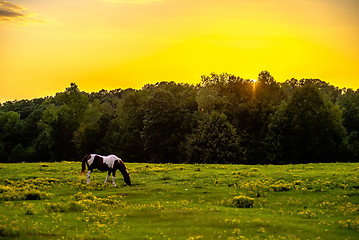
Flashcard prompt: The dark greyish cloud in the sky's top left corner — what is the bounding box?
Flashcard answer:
[0,1,42,22]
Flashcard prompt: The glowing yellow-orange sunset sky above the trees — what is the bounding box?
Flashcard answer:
[0,0,359,102]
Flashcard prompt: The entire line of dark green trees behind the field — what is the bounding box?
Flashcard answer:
[0,71,359,164]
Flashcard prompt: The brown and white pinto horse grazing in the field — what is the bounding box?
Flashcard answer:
[81,154,131,187]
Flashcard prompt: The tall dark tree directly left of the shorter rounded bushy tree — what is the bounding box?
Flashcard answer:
[141,82,198,162]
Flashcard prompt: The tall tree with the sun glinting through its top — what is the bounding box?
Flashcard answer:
[232,71,288,164]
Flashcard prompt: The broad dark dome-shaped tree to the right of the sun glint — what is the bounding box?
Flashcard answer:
[267,84,345,163]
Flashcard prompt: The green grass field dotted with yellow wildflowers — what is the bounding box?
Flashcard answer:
[0,162,359,239]
